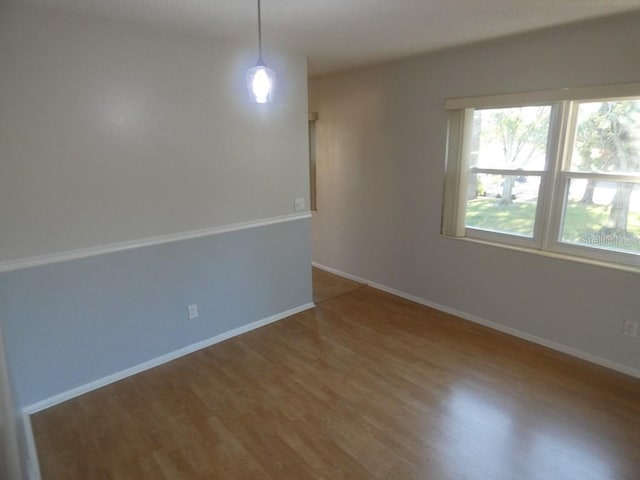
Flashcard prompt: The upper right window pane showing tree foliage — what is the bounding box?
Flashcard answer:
[571,100,640,174]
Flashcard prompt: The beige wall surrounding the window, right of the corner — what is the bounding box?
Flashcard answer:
[309,10,640,370]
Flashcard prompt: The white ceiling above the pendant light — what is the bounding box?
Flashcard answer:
[13,0,640,74]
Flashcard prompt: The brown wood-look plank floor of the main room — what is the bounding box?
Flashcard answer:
[32,272,640,480]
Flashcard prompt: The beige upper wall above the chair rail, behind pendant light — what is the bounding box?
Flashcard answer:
[0,7,308,263]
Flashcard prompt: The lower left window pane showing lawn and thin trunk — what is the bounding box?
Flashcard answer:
[465,174,540,238]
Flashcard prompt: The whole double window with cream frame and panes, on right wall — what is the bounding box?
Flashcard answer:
[443,84,640,267]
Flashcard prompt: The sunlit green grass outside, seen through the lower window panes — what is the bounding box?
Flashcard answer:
[466,198,640,251]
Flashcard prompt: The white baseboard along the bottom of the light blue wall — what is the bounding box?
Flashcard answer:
[22,303,315,414]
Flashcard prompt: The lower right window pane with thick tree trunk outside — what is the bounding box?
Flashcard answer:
[561,179,640,254]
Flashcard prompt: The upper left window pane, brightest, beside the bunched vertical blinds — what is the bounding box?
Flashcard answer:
[470,106,551,170]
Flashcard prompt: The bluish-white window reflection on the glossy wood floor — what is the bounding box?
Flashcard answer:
[442,387,613,480]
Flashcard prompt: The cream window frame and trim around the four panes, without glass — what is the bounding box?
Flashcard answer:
[441,83,640,270]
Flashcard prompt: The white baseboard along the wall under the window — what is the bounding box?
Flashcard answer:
[312,262,640,378]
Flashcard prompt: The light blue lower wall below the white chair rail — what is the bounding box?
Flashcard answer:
[0,219,312,407]
